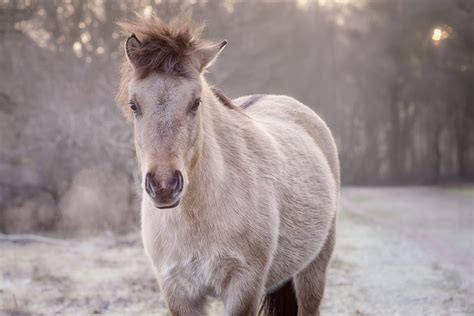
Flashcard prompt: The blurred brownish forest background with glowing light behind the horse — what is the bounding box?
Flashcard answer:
[0,0,474,233]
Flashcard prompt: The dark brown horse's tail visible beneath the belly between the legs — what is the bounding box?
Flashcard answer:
[259,279,298,316]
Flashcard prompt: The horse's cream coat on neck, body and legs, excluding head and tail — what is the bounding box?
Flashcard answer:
[139,80,339,315]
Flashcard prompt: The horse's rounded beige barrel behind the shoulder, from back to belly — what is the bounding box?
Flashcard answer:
[234,95,339,289]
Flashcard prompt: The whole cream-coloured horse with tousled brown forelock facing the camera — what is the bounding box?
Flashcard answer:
[117,15,340,316]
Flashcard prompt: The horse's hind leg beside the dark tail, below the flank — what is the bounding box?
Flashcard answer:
[294,220,336,316]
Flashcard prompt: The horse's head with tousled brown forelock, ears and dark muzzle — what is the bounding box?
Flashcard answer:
[115,17,226,208]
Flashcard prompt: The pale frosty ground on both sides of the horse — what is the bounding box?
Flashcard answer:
[0,186,474,316]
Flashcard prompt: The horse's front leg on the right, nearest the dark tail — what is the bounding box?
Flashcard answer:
[223,272,266,316]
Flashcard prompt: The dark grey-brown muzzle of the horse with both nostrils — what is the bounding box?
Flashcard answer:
[145,170,184,209]
